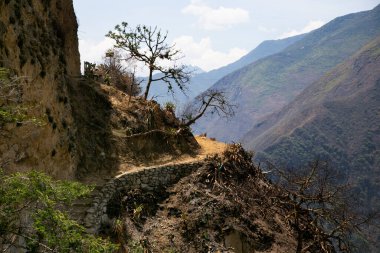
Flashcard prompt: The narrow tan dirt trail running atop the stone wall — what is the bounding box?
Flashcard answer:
[82,136,227,185]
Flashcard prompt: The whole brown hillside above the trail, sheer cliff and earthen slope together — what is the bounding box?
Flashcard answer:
[0,0,199,179]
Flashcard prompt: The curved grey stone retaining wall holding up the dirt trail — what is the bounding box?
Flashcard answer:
[84,161,203,234]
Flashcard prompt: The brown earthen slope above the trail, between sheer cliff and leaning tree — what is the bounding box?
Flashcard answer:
[70,79,199,180]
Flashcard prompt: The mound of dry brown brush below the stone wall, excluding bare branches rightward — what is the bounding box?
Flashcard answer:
[105,144,295,252]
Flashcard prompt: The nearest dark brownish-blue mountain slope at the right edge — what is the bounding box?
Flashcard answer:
[244,37,380,204]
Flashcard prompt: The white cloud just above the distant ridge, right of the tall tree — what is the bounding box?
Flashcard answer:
[174,36,248,71]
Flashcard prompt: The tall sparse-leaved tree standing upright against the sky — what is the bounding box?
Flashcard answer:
[106,22,190,99]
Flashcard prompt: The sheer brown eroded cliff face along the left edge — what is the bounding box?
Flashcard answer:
[0,0,80,178]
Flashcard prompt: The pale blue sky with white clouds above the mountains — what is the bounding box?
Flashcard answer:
[74,0,380,71]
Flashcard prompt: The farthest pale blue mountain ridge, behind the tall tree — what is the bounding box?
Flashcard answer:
[145,35,304,105]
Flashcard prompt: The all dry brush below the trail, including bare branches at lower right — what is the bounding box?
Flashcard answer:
[97,144,376,253]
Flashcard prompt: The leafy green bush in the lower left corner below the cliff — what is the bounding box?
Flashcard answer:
[0,171,118,253]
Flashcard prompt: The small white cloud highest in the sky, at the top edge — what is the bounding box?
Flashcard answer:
[182,0,249,30]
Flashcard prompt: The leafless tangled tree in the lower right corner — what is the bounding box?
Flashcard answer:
[270,161,378,253]
